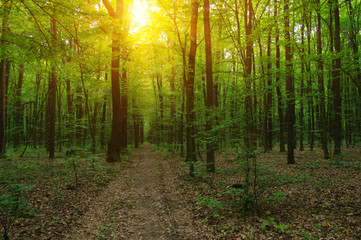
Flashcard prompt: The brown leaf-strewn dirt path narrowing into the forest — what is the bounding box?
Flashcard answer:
[67,144,200,240]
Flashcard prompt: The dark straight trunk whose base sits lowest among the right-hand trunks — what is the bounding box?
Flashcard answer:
[284,0,295,164]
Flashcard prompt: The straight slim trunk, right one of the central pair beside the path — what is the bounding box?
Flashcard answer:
[203,0,215,172]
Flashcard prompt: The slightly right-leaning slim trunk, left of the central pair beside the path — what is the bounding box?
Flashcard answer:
[186,0,199,176]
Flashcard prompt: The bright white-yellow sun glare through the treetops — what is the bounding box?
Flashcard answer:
[131,0,150,32]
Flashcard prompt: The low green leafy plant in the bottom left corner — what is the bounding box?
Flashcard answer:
[0,184,35,239]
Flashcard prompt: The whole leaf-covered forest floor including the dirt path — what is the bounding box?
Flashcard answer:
[0,144,361,240]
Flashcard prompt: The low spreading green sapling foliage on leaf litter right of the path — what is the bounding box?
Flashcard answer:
[201,150,310,215]
